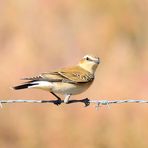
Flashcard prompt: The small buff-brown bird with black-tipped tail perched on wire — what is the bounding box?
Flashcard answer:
[12,55,100,105]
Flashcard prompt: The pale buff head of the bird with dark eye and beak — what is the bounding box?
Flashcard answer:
[79,55,100,74]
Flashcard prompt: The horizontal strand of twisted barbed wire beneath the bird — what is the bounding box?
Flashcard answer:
[0,98,148,108]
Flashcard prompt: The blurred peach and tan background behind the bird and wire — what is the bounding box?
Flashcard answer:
[0,0,148,148]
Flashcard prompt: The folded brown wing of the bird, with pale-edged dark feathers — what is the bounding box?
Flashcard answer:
[22,67,94,83]
